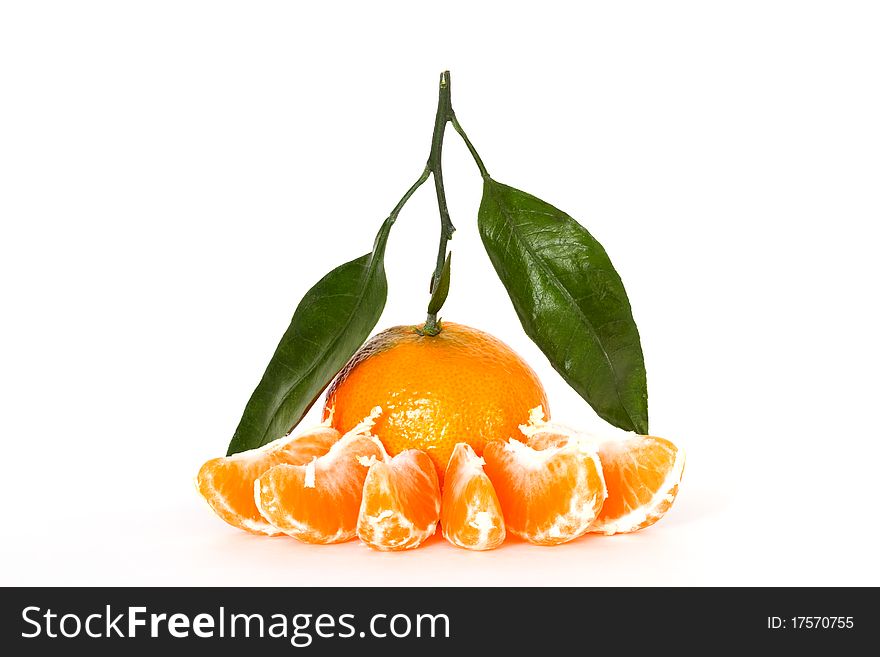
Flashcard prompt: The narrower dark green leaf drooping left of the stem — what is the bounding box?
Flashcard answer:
[227,218,394,455]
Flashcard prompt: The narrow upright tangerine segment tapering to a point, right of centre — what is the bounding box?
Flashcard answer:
[440,443,507,550]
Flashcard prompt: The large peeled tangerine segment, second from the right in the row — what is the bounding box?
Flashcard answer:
[483,409,606,545]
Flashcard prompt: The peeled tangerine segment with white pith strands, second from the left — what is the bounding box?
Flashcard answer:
[251,409,387,543]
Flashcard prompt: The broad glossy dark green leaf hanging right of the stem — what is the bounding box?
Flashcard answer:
[479,179,648,434]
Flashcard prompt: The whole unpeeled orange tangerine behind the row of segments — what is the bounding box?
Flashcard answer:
[324,322,549,478]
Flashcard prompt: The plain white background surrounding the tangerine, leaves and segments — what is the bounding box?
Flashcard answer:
[0,1,880,585]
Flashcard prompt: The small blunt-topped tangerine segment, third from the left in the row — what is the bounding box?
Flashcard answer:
[357,449,440,550]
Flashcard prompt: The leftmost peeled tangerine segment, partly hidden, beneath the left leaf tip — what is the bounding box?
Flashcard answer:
[196,426,340,536]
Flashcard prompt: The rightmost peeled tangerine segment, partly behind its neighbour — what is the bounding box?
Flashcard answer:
[590,434,685,535]
